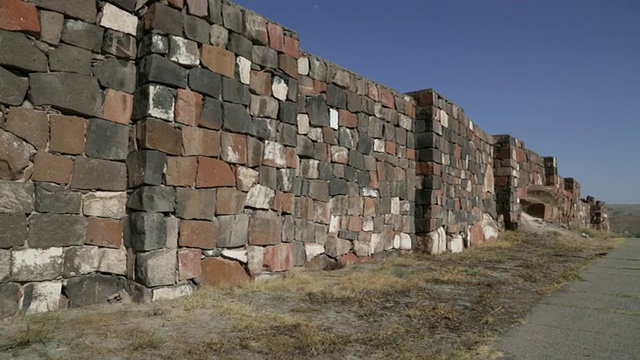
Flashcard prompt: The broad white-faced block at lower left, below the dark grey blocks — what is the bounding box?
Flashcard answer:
[11,248,64,281]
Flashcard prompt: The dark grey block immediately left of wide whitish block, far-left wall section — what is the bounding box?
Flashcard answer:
[35,182,82,214]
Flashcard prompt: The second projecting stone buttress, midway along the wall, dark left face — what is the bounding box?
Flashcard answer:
[411,90,496,253]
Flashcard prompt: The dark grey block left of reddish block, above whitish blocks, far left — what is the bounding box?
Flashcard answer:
[29,214,87,248]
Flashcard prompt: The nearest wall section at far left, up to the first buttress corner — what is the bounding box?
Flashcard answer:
[0,0,138,316]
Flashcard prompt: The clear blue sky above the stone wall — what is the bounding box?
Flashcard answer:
[237,0,640,203]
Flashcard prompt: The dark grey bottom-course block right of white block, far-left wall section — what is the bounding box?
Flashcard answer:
[64,274,125,308]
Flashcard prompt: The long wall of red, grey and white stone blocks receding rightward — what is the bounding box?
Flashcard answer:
[0,0,603,316]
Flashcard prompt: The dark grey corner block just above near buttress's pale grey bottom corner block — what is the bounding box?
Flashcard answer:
[129,212,167,251]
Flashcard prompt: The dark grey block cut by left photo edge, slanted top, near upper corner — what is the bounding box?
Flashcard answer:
[0,30,47,71]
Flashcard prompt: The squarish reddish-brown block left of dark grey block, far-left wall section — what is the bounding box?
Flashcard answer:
[49,115,86,155]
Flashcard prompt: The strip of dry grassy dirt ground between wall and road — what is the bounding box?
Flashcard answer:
[0,231,622,360]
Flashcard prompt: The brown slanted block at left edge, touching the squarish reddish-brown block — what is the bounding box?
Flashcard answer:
[5,107,49,150]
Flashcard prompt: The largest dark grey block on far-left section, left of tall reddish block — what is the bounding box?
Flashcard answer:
[29,73,102,117]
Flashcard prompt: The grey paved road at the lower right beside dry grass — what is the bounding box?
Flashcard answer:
[497,239,640,360]
